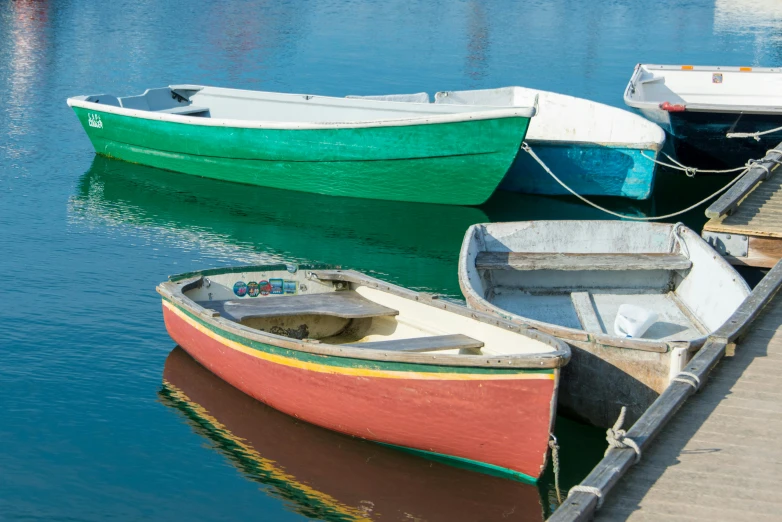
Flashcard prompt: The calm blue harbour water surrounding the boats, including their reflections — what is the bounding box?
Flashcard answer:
[0,0,782,521]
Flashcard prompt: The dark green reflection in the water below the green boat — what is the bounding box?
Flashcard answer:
[70,156,488,295]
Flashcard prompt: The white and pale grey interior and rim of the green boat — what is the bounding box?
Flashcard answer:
[75,85,534,123]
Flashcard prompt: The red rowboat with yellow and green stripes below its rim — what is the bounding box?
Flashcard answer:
[157,265,570,481]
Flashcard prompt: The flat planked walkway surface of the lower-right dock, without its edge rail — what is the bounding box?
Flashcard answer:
[595,297,782,521]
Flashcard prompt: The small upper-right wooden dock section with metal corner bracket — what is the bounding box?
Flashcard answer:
[703,143,782,268]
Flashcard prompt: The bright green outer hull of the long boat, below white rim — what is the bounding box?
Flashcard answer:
[73,107,529,205]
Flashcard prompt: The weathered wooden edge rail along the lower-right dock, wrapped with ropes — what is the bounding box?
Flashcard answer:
[549,261,782,522]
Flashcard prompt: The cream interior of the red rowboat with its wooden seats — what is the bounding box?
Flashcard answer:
[179,270,557,355]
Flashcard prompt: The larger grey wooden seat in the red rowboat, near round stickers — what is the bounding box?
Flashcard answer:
[198,291,399,322]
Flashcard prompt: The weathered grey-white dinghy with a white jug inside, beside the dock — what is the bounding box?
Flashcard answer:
[459,221,750,427]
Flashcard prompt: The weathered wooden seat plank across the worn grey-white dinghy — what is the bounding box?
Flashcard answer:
[475,252,692,271]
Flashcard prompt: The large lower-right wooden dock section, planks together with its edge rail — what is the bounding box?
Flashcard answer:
[549,263,782,521]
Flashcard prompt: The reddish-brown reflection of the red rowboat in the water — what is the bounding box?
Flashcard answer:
[159,347,543,522]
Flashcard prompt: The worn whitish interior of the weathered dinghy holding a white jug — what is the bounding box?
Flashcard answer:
[460,221,749,341]
